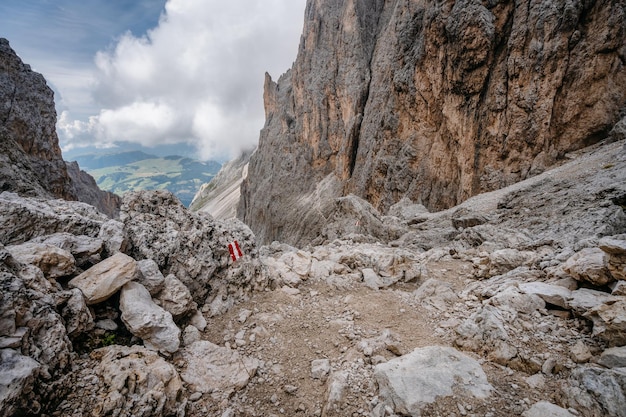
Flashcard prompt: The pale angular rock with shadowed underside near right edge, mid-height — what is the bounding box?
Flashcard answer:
[563,248,613,286]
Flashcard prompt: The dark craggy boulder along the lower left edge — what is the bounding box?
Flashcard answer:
[0,244,73,415]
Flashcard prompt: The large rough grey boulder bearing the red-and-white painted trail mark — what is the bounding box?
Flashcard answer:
[120,191,267,315]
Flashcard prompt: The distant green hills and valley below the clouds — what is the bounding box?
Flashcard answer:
[74,151,221,207]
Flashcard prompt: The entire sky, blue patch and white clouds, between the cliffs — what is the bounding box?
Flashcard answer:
[0,0,306,159]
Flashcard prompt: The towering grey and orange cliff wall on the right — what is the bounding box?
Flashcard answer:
[238,0,626,244]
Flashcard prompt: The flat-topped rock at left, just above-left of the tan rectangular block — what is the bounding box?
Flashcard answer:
[6,242,76,279]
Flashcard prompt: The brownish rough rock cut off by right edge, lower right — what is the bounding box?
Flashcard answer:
[585,298,626,347]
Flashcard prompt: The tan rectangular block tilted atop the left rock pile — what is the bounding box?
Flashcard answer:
[68,253,138,305]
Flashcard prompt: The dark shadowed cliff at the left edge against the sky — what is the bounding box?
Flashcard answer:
[0,39,120,215]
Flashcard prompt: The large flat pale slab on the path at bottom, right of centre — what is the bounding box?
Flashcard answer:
[374,346,493,416]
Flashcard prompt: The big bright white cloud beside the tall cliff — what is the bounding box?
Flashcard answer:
[58,0,305,158]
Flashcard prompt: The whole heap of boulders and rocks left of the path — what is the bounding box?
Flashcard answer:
[0,192,266,415]
